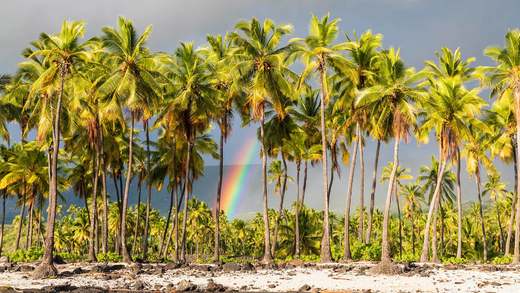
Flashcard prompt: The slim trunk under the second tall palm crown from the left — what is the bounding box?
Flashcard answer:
[121,112,135,263]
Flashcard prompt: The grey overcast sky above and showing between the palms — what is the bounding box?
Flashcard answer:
[0,0,520,217]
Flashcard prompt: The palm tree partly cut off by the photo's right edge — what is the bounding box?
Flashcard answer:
[484,29,520,263]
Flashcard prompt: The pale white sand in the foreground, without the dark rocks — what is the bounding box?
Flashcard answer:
[0,264,520,292]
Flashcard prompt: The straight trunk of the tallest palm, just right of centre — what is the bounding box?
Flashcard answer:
[320,66,332,262]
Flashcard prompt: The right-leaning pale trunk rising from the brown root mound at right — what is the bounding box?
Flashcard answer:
[381,136,400,263]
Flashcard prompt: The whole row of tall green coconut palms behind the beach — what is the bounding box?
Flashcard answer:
[0,15,520,276]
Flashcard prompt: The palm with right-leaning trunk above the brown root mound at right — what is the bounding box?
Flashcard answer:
[356,48,423,265]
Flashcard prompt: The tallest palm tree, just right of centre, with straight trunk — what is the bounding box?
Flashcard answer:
[291,15,354,262]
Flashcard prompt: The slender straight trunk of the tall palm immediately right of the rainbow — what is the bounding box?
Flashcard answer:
[260,105,273,264]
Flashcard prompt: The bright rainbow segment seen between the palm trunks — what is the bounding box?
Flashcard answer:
[221,137,258,218]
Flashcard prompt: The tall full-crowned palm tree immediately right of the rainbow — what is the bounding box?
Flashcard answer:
[231,18,293,263]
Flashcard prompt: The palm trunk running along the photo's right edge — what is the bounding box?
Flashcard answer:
[513,84,520,264]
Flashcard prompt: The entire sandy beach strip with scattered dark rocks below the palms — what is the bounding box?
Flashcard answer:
[0,263,520,292]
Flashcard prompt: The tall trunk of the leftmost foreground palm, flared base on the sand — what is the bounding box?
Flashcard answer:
[34,68,66,278]
